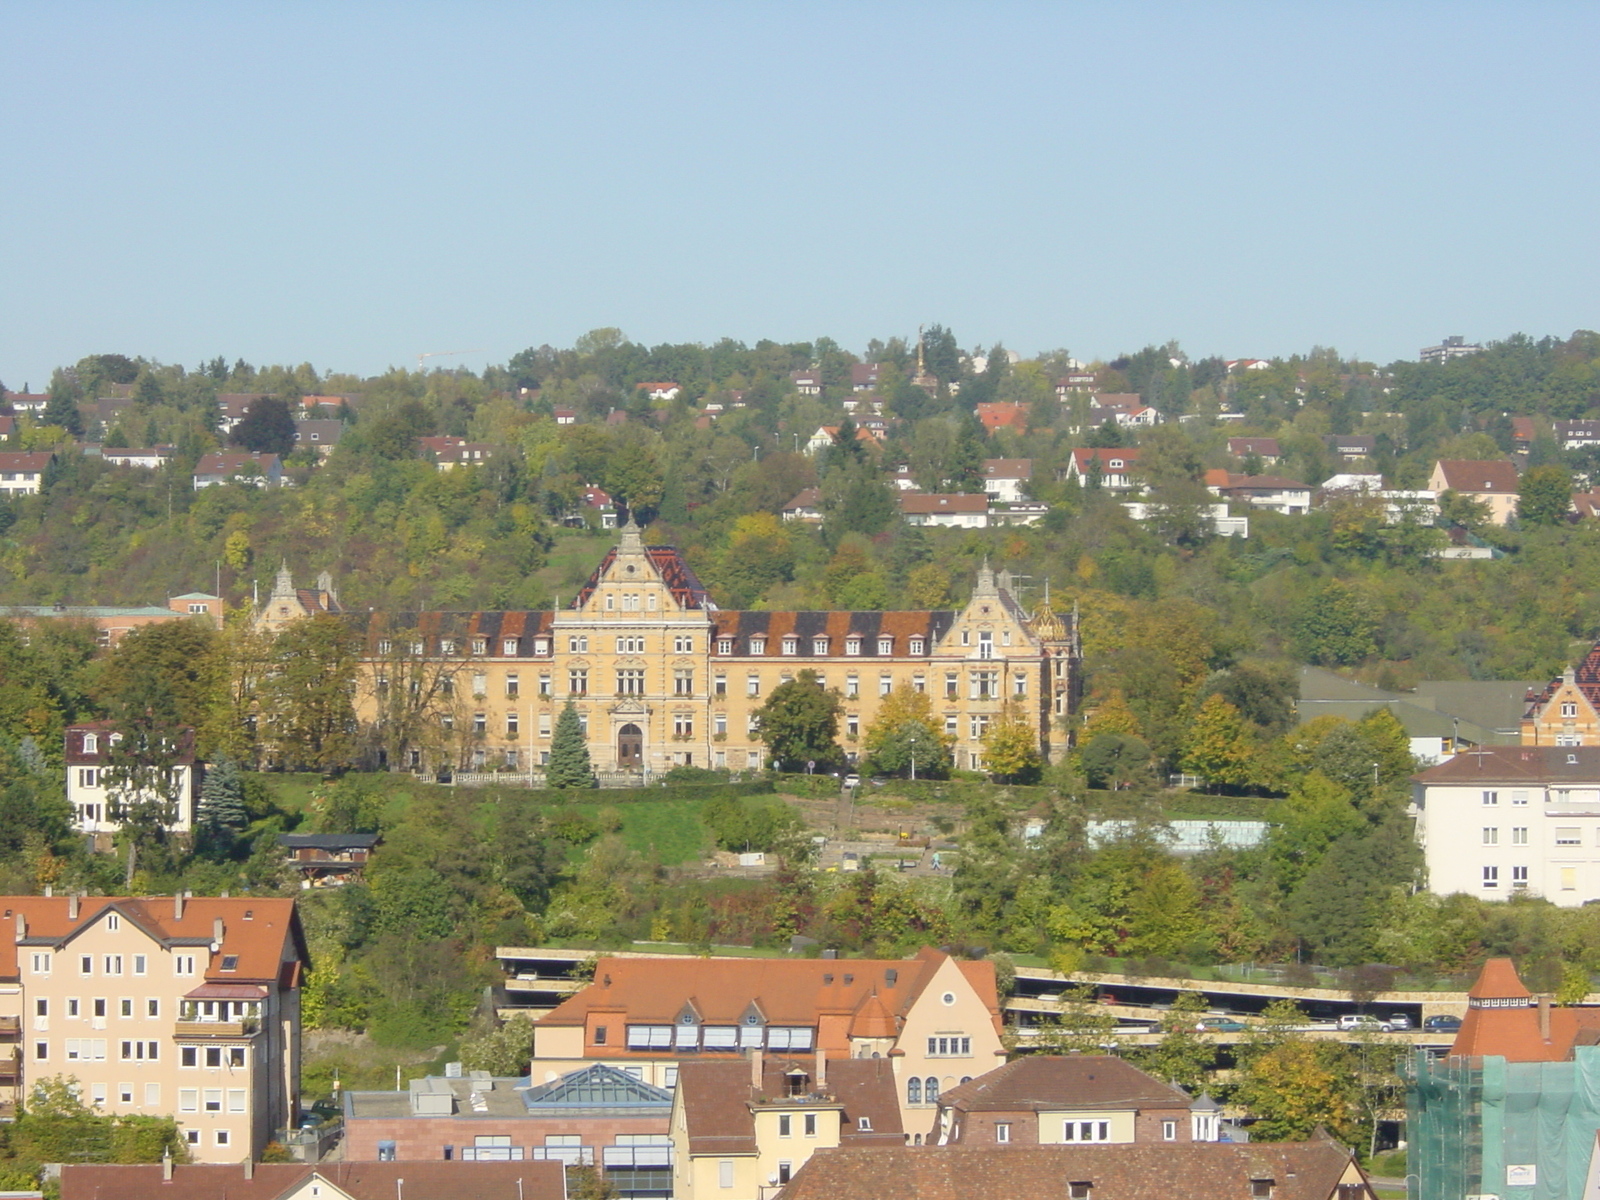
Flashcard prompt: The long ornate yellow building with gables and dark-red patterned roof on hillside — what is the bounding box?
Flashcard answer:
[312,525,1080,782]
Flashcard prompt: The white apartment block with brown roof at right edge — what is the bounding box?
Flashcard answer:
[1414,746,1600,909]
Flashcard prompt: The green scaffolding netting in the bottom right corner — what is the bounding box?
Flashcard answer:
[1406,1046,1600,1200]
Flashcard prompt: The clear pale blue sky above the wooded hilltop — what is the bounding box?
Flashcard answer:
[0,0,1600,389]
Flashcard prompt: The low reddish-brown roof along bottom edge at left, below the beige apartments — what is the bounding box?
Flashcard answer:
[61,1158,566,1200]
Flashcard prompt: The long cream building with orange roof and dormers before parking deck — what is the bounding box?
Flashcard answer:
[531,949,1005,1136]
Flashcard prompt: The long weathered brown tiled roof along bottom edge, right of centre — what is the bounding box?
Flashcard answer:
[782,1134,1376,1200]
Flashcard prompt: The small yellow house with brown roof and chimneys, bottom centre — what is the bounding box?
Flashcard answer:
[672,1050,907,1200]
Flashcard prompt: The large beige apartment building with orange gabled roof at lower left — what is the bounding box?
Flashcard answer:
[0,896,307,1163]
